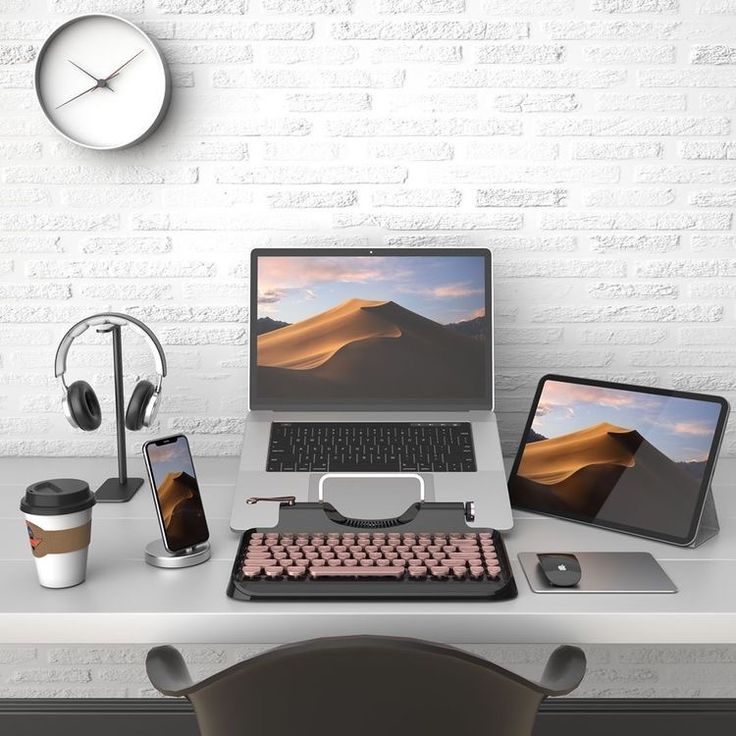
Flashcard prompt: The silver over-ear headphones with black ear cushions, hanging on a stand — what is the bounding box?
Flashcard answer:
[54,312,166,432]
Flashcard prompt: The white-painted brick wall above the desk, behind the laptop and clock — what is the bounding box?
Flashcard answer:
[0,0,736,458]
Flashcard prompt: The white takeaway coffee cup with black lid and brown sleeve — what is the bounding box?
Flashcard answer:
[20,478,95,588]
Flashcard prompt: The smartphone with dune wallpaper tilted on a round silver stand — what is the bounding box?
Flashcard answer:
[143,434,210,552]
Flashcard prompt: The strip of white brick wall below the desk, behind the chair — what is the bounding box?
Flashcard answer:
[0,644,736,698]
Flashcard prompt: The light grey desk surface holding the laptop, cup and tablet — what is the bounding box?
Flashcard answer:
[0,458,736,644]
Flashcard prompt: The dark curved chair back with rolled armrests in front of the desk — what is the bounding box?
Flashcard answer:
[146,636,586,736]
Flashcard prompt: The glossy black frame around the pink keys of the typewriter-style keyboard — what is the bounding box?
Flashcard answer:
[227,502,518,601]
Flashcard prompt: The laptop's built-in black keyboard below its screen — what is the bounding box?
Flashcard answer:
[266,422,476,473]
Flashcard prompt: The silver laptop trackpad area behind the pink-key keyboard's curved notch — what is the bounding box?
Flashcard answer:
[309,473,433,519]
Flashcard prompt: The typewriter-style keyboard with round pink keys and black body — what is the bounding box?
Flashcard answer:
[227,499,516,600]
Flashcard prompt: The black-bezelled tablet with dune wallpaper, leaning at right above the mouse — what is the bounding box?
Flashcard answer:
[509,375,729,546]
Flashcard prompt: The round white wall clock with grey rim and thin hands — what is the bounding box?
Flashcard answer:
[36,15,170,149]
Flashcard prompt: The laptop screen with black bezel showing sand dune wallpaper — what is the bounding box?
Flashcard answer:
[250,249,493,409]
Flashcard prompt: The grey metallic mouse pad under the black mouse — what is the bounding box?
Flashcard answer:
[518,550,677,594]
